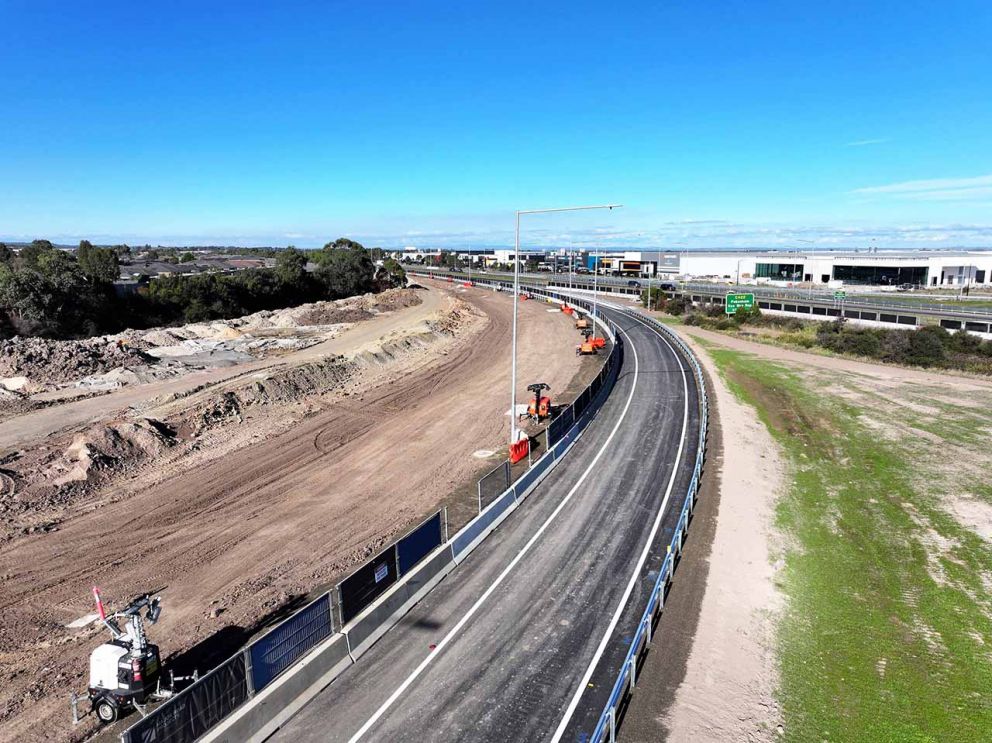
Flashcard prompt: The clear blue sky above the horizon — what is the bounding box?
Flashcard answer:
[0,0,992,247]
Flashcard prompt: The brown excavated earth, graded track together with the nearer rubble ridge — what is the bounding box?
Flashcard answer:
[0,289,594,741]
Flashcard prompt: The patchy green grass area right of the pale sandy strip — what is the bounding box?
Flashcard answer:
[710,349,992,743]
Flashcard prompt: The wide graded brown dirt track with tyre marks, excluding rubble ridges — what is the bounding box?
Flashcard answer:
[0,288,592,741]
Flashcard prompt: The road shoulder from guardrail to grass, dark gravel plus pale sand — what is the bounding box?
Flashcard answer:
[620,328,783,742]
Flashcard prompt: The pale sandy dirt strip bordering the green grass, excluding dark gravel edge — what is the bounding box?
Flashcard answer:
[664,332,783,743]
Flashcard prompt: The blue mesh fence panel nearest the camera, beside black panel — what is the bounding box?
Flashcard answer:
[248,593,334,693]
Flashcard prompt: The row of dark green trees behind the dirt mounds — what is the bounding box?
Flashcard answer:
[0,238,406,338]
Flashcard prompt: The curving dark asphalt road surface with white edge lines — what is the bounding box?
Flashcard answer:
[271,310,699,743]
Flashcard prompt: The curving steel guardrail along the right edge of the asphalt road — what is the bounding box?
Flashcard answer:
[589,309,709,743]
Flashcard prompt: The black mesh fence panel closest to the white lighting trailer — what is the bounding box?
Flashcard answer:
[121,653,248,743]
